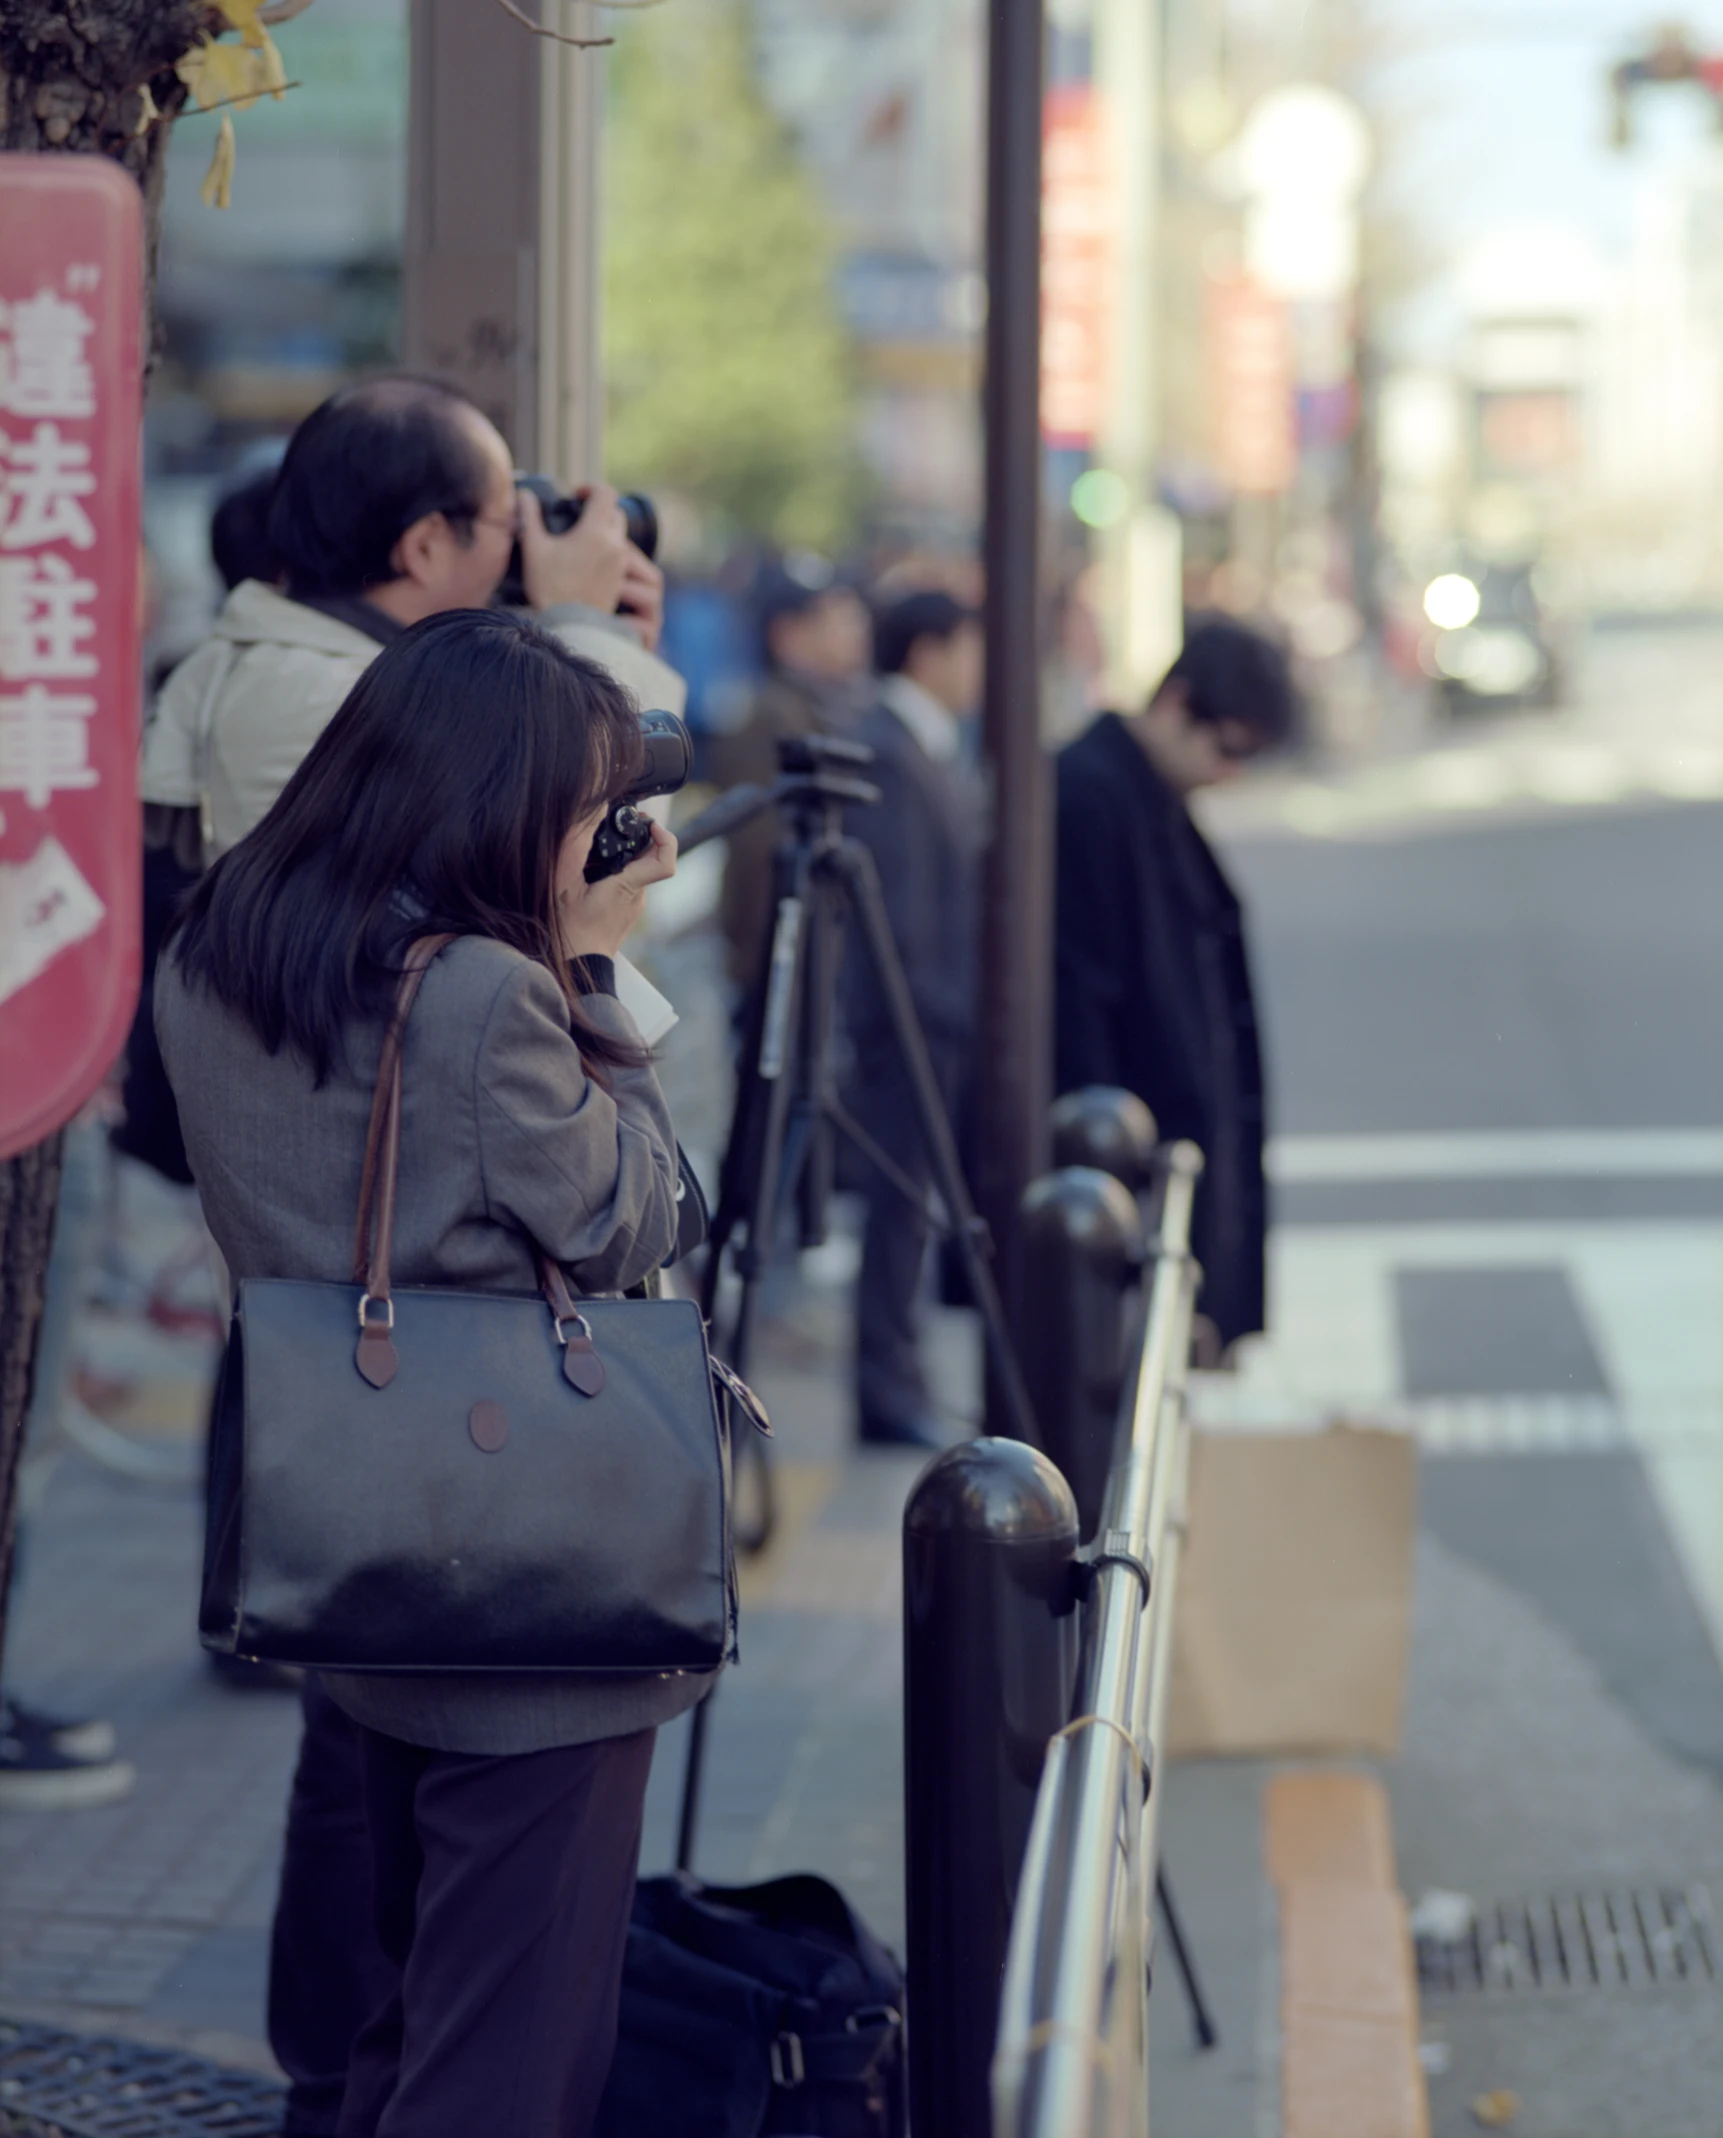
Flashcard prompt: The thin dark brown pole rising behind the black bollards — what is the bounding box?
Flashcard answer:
[975,0,1052,1432]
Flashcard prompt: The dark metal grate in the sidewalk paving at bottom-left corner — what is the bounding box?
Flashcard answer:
[0,2018,282,2138]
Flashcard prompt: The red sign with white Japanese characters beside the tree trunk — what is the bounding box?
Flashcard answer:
[0,154,143,1157]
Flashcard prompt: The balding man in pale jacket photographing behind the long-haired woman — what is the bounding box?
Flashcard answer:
[143,376,684,2138]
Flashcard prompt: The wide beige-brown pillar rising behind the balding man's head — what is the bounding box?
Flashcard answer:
[402,0,605,483]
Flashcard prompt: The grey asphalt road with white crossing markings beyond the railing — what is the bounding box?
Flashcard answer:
[1150,662,1723,2138]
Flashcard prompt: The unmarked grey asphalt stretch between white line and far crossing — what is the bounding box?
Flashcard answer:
[1227,804,1723,1135]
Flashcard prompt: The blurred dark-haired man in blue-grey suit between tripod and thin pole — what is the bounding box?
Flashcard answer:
[842,590,983,1447]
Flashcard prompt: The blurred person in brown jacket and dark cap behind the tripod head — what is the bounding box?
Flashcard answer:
[712,556,868,1003]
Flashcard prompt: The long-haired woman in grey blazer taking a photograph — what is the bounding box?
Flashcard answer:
[156,609,710,2138]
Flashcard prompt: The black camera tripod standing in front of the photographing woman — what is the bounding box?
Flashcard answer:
[676,735,1039,1871]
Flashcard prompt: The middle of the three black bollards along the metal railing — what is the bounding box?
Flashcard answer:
[1020,1171,1144,1539]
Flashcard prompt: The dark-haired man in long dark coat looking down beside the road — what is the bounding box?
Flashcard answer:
[1054,616,1295,1347]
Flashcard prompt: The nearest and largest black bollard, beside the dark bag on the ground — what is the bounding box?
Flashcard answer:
[904,1439,1077,2138]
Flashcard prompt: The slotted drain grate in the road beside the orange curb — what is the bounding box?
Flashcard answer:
[1417,1886,1723,1999]
